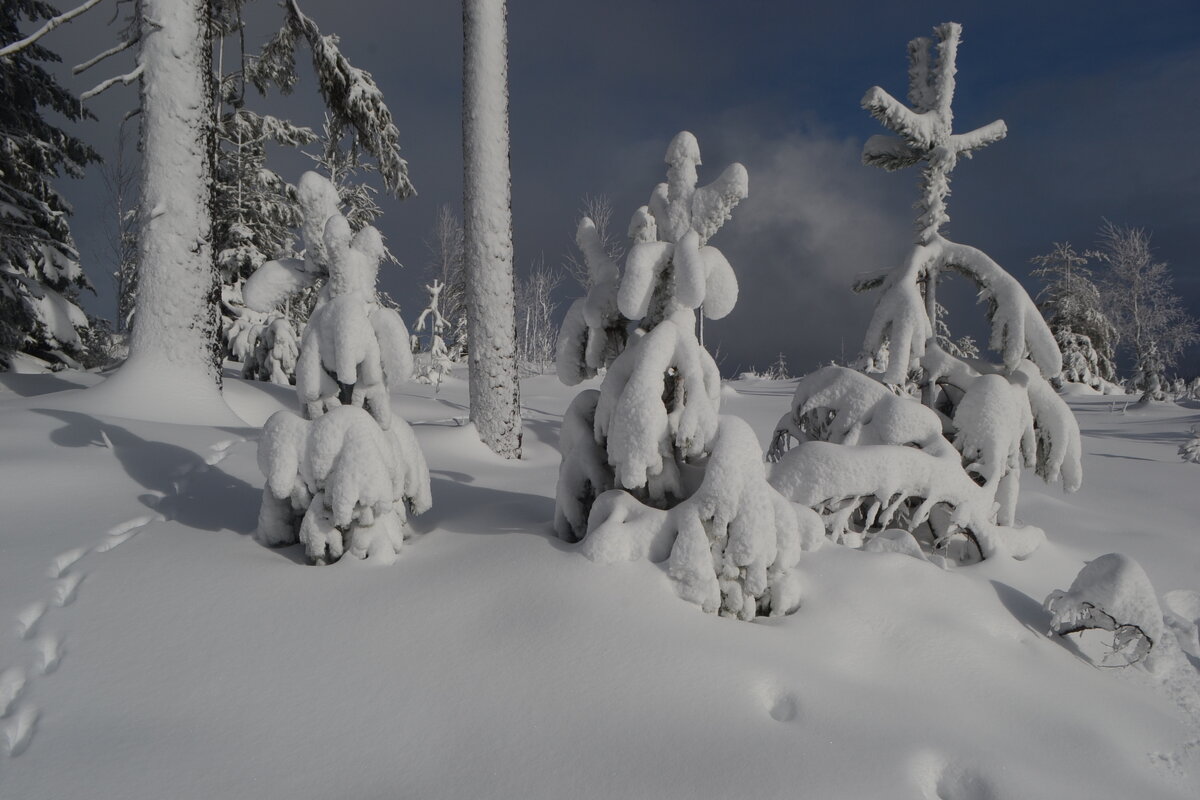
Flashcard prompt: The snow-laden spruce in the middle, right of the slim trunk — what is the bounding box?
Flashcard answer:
[554,132,806,619]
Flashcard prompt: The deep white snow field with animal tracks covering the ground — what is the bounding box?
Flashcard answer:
[0,373,1200,800]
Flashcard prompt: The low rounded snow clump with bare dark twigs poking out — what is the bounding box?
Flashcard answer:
[1045,553,1163,666]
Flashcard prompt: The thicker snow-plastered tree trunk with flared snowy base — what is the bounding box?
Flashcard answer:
[97,0,236,423]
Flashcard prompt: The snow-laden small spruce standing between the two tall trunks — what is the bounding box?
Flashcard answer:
[247,173,430,564]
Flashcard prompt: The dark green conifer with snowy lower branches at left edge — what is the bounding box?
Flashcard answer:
[0,0,98,369]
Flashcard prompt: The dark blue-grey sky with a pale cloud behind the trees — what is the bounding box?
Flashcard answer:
[47,0,1200,373]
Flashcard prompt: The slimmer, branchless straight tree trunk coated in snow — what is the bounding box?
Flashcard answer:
[462,0,521,458]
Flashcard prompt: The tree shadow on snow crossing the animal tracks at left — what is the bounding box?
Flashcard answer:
[32,409,262,534]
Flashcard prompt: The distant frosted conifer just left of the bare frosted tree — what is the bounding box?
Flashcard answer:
[1031,242,1117,389]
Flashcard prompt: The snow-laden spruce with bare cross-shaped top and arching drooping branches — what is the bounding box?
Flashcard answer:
[770,23,1081,558]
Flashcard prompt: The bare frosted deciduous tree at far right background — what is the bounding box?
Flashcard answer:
[1088,222,1200,401]
